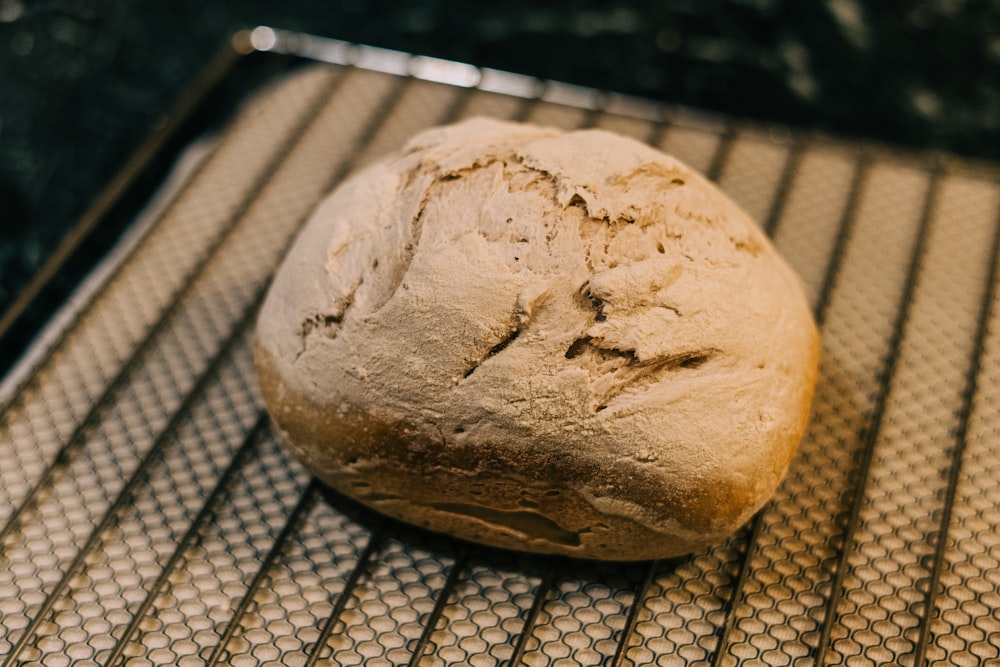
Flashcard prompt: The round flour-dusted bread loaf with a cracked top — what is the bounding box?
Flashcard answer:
[255,119,818,560]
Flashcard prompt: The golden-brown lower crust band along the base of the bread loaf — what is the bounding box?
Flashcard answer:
[254,320,819,561]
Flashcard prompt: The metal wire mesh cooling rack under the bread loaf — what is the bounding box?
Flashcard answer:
[0,34,1000,667]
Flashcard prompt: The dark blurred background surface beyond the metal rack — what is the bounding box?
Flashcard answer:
[0,0,1000,350]
